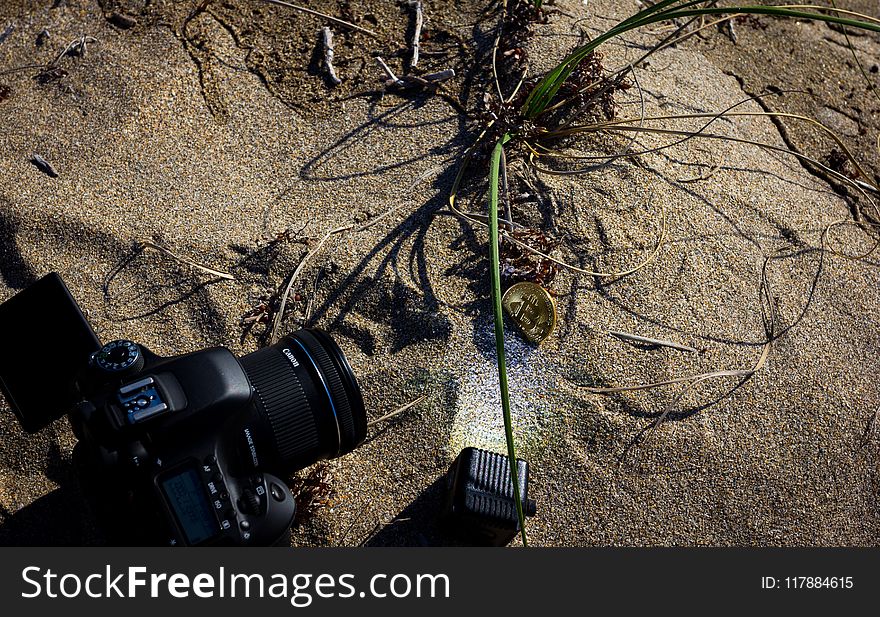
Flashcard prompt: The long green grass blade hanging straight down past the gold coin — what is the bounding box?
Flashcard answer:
[489,133,528,546]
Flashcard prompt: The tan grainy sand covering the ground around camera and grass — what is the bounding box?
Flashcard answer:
[0,0,880,546]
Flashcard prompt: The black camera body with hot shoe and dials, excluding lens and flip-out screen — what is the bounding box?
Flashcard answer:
[70,341,294,545]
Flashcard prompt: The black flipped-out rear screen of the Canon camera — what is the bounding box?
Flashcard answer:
[0,272,101,432]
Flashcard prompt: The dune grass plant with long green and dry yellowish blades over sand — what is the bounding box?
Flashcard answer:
[449,0,880,545]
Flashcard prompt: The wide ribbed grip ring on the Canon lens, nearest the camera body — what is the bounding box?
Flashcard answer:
[240,347,320,462]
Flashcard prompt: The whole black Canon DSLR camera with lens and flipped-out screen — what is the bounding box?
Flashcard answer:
[0,273,366,545]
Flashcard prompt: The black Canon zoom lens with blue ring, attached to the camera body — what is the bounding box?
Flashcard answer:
[239,328,367,473]
